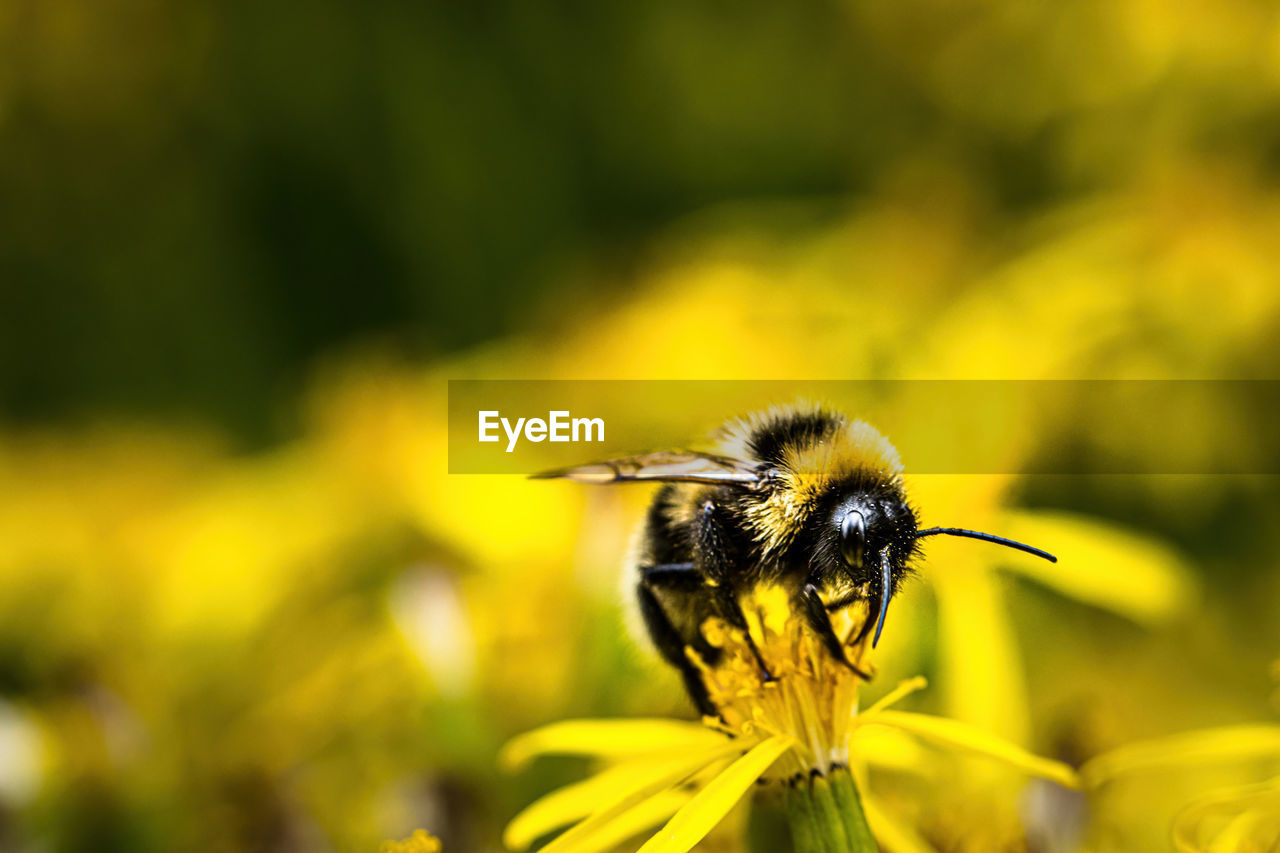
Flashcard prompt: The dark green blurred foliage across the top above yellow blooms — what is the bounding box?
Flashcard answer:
[0,0,1280,441]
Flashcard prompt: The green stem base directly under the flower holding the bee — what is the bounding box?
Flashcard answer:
[787,768,879,853]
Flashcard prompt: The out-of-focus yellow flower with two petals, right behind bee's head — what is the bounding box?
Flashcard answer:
[906,471,1197,743]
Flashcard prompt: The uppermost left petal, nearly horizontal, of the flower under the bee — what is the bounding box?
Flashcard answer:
[498,719,726,771]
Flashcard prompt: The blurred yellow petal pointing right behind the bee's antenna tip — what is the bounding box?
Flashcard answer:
[1000,511,1196,625]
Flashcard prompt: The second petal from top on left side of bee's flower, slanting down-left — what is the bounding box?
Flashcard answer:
[502,738,741,850]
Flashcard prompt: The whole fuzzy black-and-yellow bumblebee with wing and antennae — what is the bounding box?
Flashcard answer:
[534,406,1056,715]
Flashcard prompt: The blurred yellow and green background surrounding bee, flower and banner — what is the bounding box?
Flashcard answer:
[0,0,1280,853]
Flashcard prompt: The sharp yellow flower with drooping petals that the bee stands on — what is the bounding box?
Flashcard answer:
[500,588,1076,853]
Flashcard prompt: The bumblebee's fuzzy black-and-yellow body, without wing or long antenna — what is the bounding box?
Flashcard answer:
[628,409,918,713]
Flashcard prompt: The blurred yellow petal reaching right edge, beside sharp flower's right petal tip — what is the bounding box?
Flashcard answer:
[1080,725,1280,788]
